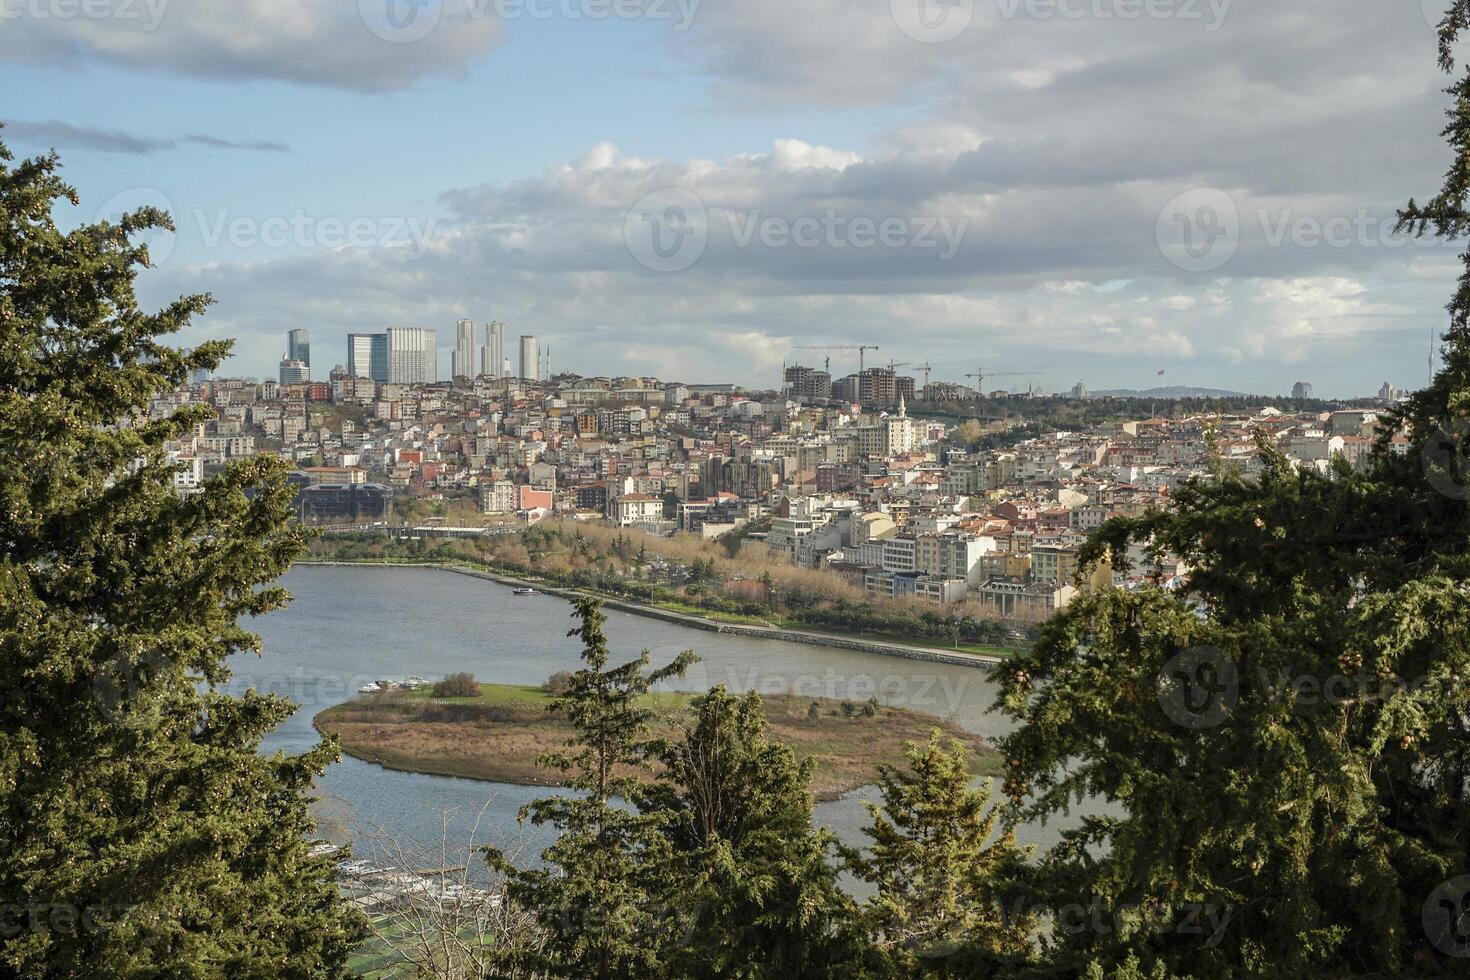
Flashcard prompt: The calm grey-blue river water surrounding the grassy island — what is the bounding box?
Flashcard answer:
[231,567,1105,860]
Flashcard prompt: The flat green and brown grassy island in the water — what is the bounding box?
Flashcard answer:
[316,685,1000,799]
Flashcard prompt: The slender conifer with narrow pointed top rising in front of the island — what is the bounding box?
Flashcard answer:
[487,598,697,980]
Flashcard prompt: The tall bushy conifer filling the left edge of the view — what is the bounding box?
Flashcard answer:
[0,135,362,977]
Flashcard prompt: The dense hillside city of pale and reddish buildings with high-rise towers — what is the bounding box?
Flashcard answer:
[150,320,1408,624]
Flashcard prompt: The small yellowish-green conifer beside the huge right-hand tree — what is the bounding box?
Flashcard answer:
[848,730,1035,976]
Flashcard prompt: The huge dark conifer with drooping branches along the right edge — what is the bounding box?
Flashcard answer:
[1001,9,1470,977]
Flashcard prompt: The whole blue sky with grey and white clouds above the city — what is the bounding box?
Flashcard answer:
[0,0,1460,397]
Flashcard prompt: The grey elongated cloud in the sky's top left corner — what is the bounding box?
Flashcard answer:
[0,0,503,93]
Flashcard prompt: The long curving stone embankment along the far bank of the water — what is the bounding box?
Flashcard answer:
[293,558,1005,670]
